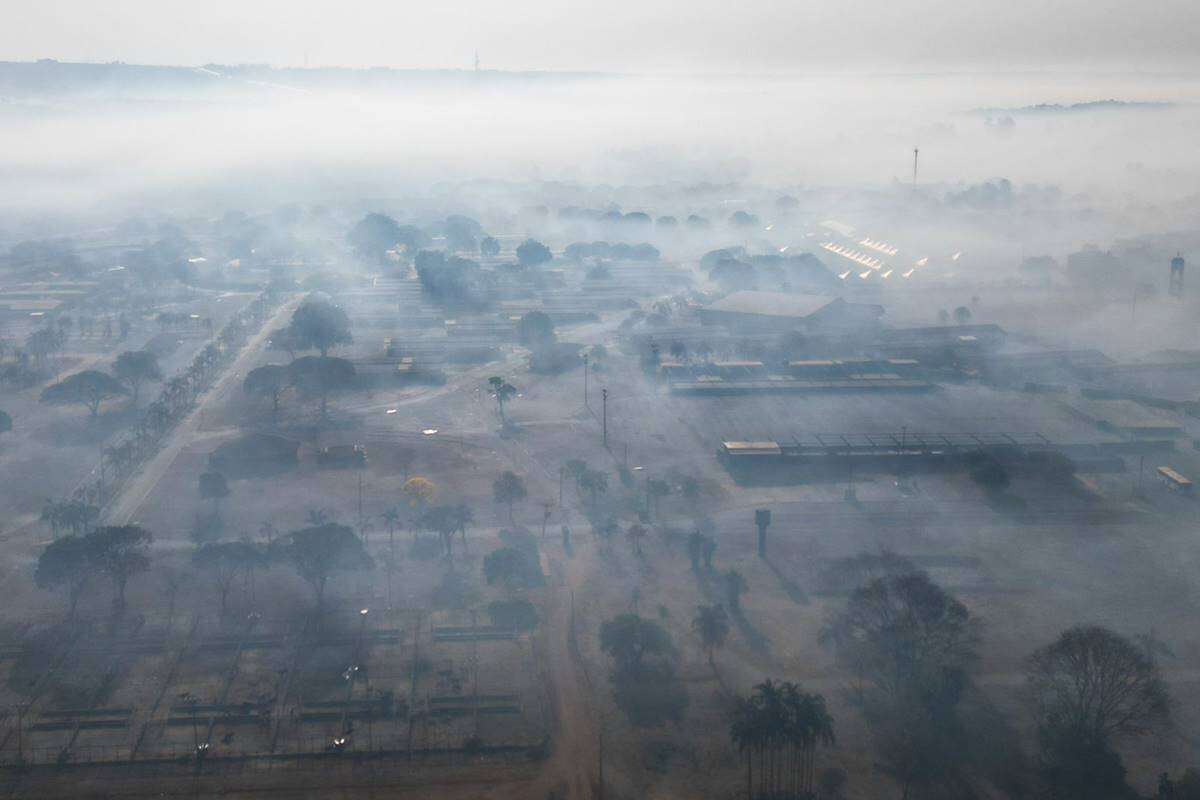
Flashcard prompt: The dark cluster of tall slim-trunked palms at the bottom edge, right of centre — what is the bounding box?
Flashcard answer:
[730,680,834,800]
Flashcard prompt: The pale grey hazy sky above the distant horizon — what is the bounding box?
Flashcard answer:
[7,0,1200,72]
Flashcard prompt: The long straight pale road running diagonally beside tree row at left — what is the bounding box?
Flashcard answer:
[107,297,301,525]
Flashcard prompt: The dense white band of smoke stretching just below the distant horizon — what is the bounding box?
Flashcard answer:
[7,67,1200,222]
